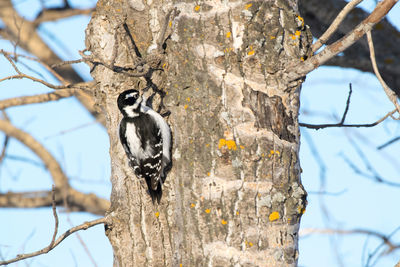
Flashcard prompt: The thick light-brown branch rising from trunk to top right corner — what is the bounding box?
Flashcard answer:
[288,0,398,80]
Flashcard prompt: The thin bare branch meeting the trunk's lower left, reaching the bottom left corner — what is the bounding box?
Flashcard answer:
[0,217,107,265]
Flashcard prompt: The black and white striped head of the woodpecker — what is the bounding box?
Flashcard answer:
[117,89,143,118]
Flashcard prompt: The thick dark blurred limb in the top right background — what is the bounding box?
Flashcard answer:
[299,0,400,97]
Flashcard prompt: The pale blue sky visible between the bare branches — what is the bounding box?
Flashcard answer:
[0,0,400,267]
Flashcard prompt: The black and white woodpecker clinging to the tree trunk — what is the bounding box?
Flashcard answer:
[117,89,172,203]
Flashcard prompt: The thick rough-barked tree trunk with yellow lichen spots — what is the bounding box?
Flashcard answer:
[86,0,312,266]
